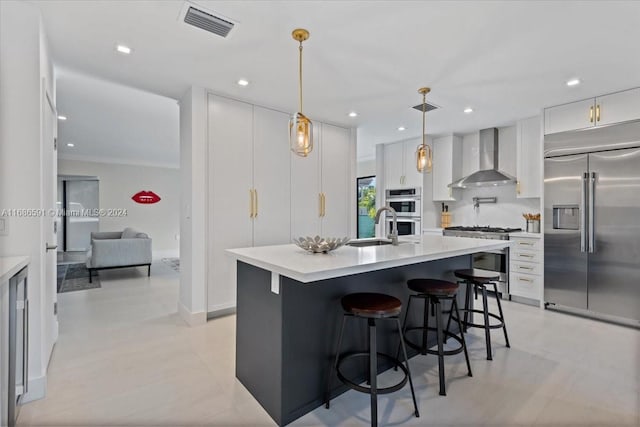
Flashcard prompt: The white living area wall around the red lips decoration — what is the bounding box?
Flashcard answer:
[58,159,180,256]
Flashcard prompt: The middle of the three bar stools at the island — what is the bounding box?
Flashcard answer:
[398,279,473,396]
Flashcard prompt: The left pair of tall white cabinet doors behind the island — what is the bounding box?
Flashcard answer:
[207,95,291,312]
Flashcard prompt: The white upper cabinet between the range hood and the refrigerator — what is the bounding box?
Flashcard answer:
[516,116,542,198]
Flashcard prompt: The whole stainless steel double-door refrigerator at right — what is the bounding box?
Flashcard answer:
[544,123,640,321]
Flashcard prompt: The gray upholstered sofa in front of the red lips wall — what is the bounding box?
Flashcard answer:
[86,227,151,282]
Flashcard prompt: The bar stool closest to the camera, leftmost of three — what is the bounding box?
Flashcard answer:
[325,293,420,426]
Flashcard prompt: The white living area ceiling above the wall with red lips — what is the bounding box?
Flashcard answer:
[56,68,180,168]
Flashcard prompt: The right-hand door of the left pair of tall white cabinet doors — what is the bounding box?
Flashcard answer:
[253,106,291,246]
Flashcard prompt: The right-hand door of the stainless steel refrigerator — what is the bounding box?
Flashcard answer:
[588,148,640,320]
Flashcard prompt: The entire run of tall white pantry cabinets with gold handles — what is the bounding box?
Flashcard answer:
[208,94,355,313]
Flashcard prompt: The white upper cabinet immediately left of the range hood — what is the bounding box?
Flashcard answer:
[432,135,462,201]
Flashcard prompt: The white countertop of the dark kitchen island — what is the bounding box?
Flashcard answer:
[227,235,511,283]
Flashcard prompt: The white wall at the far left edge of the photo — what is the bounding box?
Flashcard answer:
[0,0,55,401]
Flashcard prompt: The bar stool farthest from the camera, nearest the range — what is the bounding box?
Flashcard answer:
[453,268,511,360]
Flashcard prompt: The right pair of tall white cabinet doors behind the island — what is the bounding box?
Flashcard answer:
[291,122,355,237]
